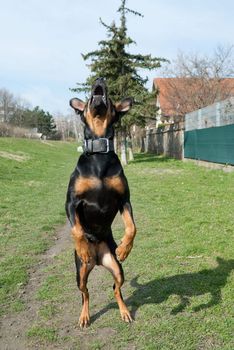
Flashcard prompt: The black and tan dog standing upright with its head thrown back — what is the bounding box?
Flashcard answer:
[66,78,136,327]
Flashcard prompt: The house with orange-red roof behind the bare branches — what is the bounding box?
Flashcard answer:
[153,77,234,124]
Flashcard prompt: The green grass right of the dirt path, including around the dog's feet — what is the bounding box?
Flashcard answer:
[28,155,234,350]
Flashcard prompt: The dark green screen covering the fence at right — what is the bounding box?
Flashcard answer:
[184,124,234,165]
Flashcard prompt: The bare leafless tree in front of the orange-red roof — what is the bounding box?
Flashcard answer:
[162,45,234,116]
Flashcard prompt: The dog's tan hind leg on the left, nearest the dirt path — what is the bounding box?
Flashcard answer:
[75,250,95,328]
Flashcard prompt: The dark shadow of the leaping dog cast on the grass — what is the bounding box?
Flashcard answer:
[91,257,234,322]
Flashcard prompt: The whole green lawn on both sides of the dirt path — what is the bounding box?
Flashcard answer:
[0,139,234,350]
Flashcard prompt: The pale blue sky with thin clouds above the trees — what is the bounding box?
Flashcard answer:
[0,0,234,113]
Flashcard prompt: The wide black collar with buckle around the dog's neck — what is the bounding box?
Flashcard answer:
[83,137,114,154]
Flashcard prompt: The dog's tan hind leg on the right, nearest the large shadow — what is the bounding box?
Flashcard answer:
[98,242,132,322]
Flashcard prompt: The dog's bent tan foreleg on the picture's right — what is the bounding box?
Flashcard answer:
[116,208,136,261]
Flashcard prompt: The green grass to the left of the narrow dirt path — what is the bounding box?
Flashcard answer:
[0,138,77,313]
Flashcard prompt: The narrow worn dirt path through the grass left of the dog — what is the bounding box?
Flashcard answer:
[0,223,72,350]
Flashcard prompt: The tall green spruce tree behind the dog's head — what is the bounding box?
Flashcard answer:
[72,0,166,163]
